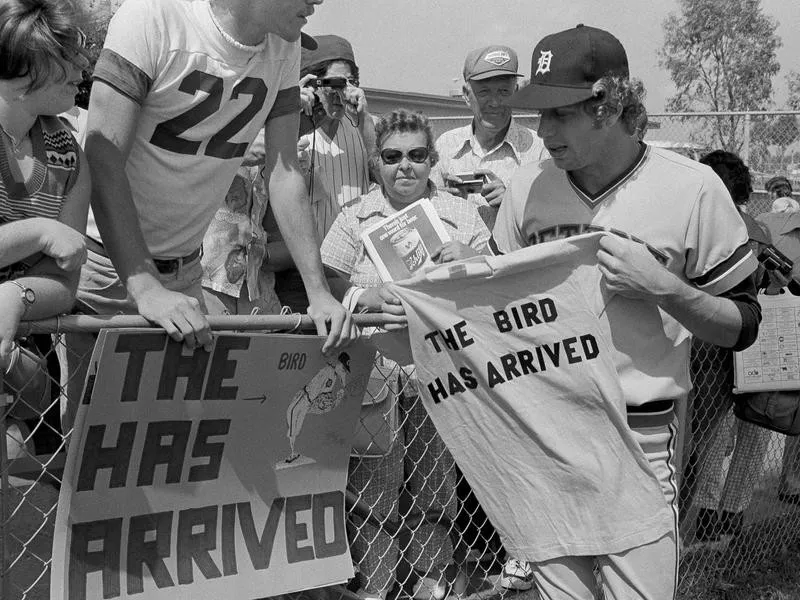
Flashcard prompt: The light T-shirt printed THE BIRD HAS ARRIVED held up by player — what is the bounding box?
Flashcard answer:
[392,233,673,561]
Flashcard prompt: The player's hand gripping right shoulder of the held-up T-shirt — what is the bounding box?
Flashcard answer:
[597,233,675,299]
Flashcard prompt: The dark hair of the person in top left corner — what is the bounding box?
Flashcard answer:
[0,0,85,92]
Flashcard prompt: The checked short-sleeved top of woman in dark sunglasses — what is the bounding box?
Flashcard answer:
[320,181,490,288]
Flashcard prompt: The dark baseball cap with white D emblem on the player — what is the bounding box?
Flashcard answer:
[507,24,629,109]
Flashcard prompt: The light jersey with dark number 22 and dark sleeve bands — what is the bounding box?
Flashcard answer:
[89,0,300,257]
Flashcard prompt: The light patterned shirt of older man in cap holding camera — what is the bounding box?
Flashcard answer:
[431,118,550,204]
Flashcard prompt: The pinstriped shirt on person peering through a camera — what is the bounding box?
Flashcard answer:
[301,118,369,239]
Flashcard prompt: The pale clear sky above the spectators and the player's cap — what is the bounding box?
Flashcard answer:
[305,0,800,113]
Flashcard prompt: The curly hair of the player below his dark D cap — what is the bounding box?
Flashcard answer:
[584,75,647,139]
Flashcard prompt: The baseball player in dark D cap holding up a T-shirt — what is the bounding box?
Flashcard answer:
[490,25,760,600]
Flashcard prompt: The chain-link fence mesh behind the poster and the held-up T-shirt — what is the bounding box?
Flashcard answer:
[0,310,800,600]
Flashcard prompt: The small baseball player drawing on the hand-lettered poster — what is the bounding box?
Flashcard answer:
[286,352,350,463]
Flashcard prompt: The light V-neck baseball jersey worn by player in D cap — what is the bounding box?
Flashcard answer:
[492,144,758,405]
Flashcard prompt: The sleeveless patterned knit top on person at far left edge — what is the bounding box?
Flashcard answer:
[0,117,80,278]
